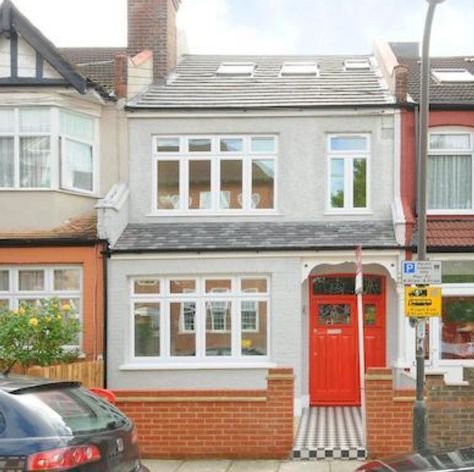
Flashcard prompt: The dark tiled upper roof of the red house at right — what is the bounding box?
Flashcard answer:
[398,56,474,105]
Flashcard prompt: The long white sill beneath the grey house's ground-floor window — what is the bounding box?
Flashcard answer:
[119,361,276,371]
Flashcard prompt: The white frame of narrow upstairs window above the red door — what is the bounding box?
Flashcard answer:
[326,133,372,214]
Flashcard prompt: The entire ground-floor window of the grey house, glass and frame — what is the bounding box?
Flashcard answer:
[131,277,270,364]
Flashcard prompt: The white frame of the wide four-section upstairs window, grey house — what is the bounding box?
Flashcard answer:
[150,134,278,216]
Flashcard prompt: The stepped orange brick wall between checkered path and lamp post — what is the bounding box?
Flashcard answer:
[366,368,415,458]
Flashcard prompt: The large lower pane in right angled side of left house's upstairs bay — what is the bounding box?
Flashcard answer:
[61,139,94,192]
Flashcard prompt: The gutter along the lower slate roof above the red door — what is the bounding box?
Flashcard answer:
[110,244,406,255]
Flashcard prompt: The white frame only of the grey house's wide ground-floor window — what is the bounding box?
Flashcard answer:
[126,274,271,368]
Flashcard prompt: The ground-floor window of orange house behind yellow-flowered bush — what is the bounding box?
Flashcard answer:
[0,265,82,348]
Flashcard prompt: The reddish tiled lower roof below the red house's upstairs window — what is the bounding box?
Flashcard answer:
[412,217,474,250]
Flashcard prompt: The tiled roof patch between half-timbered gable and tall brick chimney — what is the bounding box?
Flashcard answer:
[59,47,127,92]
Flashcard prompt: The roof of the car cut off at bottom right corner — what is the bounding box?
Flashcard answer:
[356,446,474,472]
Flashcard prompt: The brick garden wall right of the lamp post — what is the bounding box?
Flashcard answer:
[426,369,474,448]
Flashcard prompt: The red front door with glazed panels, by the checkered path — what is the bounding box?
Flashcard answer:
[310,274,385,405]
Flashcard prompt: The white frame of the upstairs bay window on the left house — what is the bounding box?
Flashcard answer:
[0,106,100,196]
